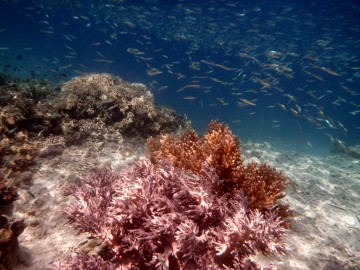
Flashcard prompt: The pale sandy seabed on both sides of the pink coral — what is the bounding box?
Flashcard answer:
[14,138,360,270]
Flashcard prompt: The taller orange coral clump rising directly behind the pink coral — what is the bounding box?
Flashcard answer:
[148,121,243,181]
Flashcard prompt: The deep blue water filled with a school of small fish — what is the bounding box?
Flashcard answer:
[0,0,360,153]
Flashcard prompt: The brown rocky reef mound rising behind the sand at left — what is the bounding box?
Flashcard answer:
[0,71,189,179]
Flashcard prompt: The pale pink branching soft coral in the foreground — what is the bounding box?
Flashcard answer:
[57,160,286,269]
